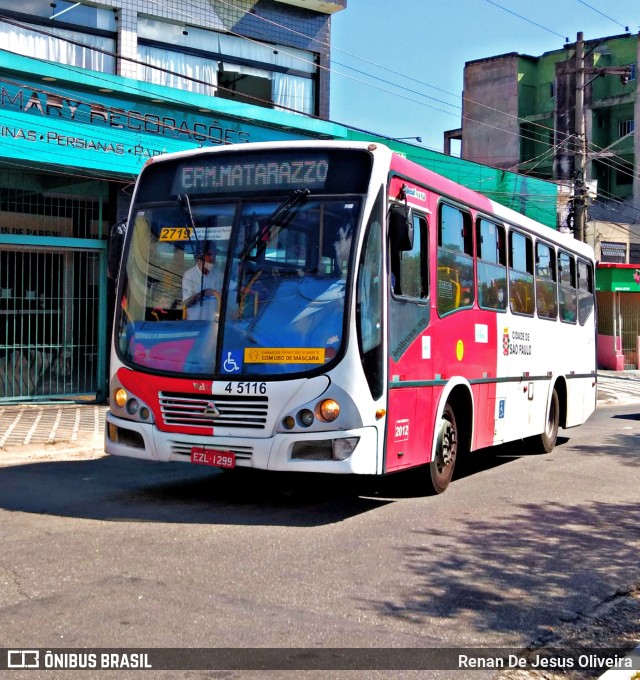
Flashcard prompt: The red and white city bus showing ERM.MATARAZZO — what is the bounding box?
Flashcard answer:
[105,141,596,493]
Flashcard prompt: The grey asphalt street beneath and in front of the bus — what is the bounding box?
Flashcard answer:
[0,405,640,677]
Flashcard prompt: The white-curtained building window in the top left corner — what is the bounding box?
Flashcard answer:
[0,0,116,73]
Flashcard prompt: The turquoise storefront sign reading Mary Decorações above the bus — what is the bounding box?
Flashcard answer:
[0,53,336,177]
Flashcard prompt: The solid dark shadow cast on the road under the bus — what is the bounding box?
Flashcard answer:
[0,440,522,526]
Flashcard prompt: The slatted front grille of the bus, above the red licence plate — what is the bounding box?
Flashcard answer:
[159,392,269,430]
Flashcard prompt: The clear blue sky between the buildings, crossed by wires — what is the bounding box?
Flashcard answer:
[330,0,640,153]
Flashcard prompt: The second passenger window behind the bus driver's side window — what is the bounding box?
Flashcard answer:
[476,218,507,310]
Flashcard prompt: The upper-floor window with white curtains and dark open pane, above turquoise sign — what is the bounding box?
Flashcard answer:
[138,17,317,114]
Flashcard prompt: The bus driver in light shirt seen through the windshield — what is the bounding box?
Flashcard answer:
[182,241,222,321]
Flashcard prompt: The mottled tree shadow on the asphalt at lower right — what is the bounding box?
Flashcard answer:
[362,502,640,642]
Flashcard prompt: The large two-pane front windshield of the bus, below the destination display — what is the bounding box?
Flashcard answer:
[116,194,362,379]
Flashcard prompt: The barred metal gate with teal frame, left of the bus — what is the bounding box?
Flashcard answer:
[0,178,107,403]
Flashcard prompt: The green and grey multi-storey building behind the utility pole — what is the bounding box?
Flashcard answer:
[458,34,640,263]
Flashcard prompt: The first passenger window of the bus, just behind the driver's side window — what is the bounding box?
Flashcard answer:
[436,203,475,316]
